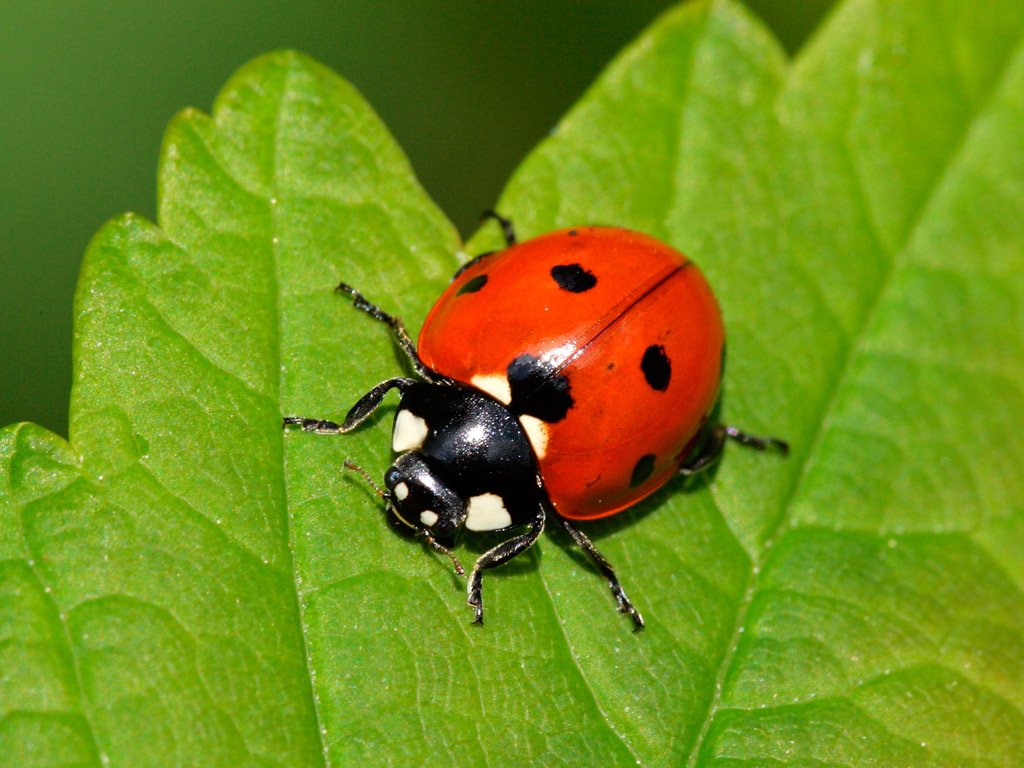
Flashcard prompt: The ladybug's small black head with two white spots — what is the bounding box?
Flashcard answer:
[384,451,466,539]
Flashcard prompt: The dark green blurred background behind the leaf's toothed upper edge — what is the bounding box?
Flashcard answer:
[0,0,831,434]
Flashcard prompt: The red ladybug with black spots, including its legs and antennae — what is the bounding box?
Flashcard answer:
[284,211,788,630]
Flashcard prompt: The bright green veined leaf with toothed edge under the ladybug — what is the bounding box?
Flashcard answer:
[0,0,1024,768]
